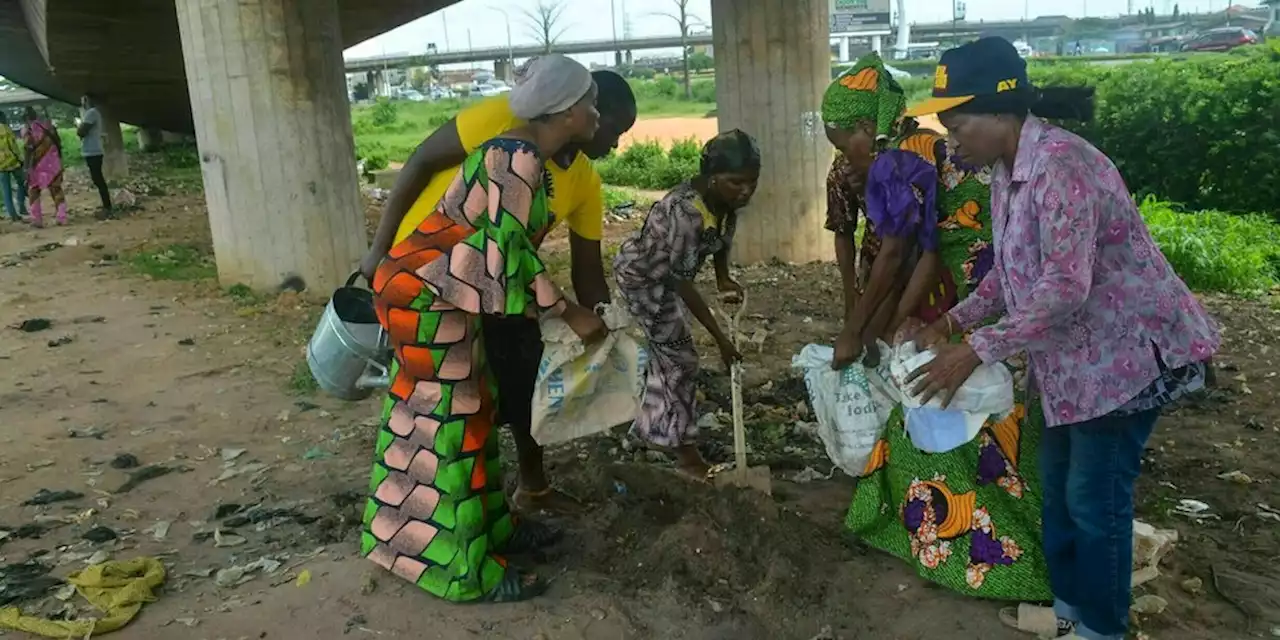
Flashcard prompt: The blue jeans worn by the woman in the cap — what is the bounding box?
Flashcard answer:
[1041,410,1160,640]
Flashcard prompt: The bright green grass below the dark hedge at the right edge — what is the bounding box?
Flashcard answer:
[1140,197,1280,297]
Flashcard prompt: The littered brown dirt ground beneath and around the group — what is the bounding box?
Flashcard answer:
[0,145,1280,640]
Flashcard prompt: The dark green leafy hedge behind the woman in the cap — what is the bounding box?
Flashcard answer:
[1032,46,1280,215]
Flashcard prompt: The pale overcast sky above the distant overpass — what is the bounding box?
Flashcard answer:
[347,0,1239,63]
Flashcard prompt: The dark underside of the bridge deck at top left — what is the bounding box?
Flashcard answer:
[0,0,458,133]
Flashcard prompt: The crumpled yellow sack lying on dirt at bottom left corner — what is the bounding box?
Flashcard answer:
[0,557,165,639]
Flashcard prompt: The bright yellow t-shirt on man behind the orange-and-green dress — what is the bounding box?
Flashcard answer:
[396,96,604,242]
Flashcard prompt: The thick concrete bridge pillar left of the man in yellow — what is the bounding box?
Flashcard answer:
[177,0,367,292]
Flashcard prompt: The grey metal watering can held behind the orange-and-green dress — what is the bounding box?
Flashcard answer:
[307,274,390,401]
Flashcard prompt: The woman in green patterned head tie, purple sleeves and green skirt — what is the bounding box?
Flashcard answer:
[823,54,1051,600]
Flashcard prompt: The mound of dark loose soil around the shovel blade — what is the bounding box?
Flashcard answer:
[555,465,850,637]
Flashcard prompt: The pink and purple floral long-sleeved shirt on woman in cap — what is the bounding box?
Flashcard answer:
[951,116,1219,426]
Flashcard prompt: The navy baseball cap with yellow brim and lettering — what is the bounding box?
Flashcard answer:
[906,37,1030,116]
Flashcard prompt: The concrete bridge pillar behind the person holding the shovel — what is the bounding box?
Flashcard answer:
[712,0,835,264]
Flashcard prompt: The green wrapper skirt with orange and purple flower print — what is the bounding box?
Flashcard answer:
[845,384,1053,602]
